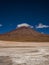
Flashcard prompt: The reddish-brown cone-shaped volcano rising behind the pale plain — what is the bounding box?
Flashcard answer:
[0,26,49,42]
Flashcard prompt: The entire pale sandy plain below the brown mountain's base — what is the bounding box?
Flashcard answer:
[0,41,49,65]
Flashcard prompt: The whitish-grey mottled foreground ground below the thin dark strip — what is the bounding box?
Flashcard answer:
[0,47,49,65]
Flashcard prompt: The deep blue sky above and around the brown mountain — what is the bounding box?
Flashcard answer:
[0,0,49,34]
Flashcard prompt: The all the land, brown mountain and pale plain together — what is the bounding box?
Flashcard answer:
[0,26,49,65]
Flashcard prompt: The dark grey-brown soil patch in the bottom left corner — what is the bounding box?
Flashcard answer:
[0,56,12,65]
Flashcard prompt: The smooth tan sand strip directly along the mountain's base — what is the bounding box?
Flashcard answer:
[0,41,49,46]
